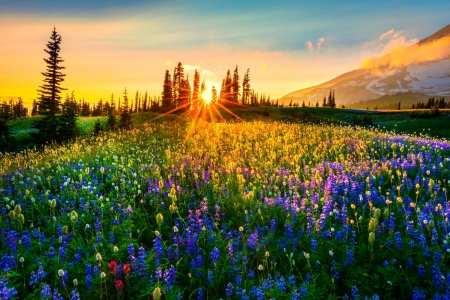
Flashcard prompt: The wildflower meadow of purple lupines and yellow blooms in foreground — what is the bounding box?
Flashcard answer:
[0,122,450,300]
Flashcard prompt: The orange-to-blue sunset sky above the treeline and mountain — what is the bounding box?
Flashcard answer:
[0,0,450,103]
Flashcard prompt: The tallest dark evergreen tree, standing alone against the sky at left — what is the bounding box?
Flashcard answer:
[31,28,66,143]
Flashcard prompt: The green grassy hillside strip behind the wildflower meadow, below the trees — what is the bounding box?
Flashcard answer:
[4,107,450,150]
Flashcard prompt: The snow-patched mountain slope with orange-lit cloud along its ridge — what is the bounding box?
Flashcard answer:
[281,25,450,105]
